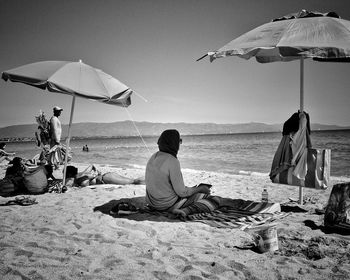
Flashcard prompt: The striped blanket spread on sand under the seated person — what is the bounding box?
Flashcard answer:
[94,197,289,230]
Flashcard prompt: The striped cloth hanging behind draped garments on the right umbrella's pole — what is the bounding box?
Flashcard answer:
[272,148,331,189]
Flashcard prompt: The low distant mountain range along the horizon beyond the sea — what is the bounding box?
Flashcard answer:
[0,121,350,140]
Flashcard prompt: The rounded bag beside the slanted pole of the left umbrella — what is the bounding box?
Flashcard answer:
[23,166,48,194]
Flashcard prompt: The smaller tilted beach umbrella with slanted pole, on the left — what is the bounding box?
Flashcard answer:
[1,61,133,184]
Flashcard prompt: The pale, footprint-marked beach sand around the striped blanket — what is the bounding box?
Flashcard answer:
[0,164,350,279]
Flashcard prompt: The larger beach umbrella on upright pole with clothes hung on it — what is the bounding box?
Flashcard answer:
[197,10,350,202]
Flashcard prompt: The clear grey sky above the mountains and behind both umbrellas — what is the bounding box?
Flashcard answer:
[0,0,350,127]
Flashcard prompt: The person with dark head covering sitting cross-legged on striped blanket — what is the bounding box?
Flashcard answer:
[145,129,216,216]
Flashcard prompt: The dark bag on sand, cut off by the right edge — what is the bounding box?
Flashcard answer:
[324,182,350,234]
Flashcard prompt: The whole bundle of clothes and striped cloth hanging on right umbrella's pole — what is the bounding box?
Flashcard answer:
[270,112,331,189]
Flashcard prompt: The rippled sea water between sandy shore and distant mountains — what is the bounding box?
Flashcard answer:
[6,130,350,178]
